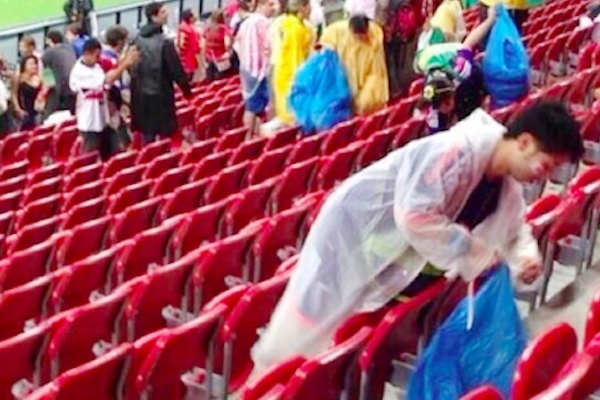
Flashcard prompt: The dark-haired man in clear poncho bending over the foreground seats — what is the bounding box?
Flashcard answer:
[253,102,583,375]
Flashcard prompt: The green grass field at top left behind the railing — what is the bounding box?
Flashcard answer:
[0,0,133,29]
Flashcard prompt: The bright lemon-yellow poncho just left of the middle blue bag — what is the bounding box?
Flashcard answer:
[273,14,313,124]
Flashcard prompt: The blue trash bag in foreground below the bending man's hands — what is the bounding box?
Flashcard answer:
[407,265,527,400]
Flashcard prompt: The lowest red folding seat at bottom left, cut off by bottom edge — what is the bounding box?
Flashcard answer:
[37,343,132,400]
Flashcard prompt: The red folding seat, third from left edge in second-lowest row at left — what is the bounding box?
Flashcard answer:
[125,255,195,341]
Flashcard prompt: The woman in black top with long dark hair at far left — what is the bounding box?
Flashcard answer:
[15,55,42,130]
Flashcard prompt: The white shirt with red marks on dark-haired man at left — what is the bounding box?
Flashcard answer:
[69,59,108,132]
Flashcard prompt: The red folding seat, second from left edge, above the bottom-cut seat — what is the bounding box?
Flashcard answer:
[42,285,133,382]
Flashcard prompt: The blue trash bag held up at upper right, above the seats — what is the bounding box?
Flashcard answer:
[483,5,529,108]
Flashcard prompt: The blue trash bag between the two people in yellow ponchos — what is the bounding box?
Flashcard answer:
[289,49,352,134]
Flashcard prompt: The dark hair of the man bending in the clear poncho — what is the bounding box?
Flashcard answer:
[504,101,583,162]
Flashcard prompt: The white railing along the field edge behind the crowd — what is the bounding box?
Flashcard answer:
[0,0,342,62]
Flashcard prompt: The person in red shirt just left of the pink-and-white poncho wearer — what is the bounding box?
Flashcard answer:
[203,10,233,81]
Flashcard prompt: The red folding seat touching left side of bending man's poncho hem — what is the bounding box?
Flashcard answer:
[217,273,290,393]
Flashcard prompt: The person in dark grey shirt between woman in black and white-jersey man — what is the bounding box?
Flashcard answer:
[42,31,77,115]
